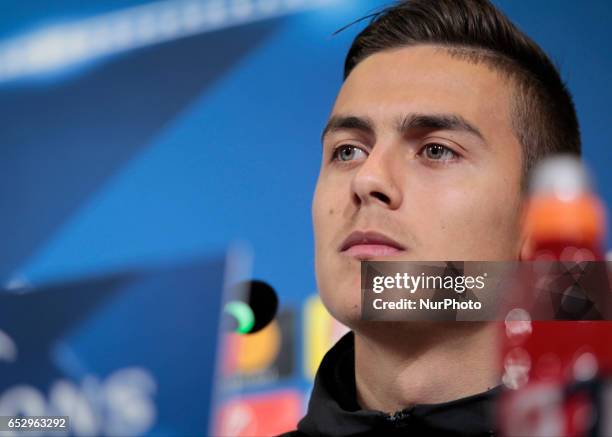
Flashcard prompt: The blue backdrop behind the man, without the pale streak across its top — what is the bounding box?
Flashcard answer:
[0,0,612,292]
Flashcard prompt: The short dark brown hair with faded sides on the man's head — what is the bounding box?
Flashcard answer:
[344,0,581,187]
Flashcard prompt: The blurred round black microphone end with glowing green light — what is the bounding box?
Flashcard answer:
[223,279,278,334]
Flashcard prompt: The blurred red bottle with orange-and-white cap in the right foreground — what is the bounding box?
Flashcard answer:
[499,156,612,437]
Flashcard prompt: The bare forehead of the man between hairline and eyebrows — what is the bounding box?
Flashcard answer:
[332,45,512,136]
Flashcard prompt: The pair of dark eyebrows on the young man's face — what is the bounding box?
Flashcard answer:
[321,114,486,142]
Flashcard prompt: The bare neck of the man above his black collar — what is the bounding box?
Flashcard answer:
[355,322,500,413]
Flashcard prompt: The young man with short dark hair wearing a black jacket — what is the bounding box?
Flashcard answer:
[282,0,580,436]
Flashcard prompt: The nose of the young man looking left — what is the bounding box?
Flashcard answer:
[351,146,402,209]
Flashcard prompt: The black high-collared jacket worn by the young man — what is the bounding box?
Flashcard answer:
[284,332,501,437]
